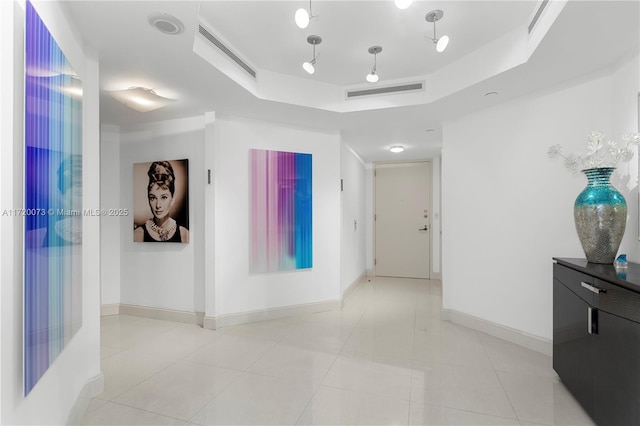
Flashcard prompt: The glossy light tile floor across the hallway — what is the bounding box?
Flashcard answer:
[82,278,593,425]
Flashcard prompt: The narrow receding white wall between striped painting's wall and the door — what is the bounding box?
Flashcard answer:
[340,143,367,295]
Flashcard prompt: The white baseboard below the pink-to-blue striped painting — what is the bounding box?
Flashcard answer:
[208,300,342,330]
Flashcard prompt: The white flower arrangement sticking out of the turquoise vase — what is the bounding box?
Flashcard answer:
[548,131,640,173]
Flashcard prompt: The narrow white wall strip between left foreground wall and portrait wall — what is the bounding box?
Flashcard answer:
[100,125,122,306]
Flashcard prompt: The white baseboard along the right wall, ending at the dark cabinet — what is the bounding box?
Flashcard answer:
[442,309,553,356]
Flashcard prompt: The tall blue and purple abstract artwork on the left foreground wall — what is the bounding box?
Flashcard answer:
[24,2,84,395]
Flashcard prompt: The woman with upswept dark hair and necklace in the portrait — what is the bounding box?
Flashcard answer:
[133,161,189,243]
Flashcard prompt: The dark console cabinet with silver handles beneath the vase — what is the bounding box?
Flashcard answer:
[553,258,640,425]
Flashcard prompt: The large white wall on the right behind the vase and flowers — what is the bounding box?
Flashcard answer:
[442,58,640,340]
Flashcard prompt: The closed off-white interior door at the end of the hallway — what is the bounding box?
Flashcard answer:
[375,162,431,278]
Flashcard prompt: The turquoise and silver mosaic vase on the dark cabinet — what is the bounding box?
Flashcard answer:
[573,167,627,264]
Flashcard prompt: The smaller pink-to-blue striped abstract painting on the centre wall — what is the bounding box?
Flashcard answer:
[249,149,313,273]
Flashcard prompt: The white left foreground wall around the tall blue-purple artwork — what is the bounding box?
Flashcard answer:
[0,1,101,424]
